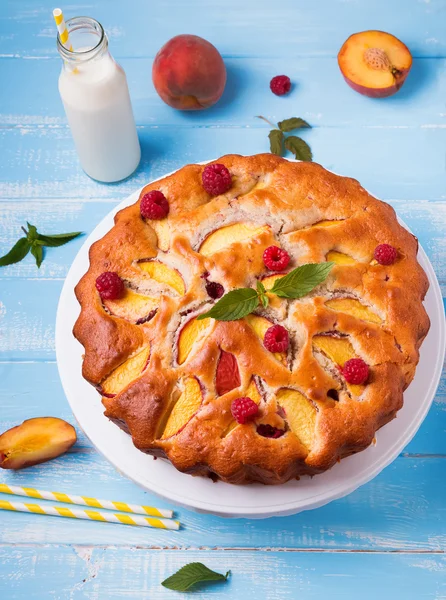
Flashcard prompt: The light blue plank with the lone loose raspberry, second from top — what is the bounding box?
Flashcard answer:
[0,57,446,127]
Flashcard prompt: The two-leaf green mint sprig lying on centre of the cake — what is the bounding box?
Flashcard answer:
[197,262,334,321]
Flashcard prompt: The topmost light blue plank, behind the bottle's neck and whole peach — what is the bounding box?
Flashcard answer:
[0,0,446,57]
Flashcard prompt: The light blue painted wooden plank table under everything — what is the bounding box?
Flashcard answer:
[0,0,446,600]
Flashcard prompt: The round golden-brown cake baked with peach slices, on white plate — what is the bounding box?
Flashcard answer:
[74,154,429,483]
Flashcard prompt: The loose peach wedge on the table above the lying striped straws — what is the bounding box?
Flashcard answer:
[0,417,77,469]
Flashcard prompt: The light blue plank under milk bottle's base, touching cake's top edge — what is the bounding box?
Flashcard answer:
[0,126,446,200]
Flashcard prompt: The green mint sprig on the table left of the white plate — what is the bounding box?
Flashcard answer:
[0,223,81,269]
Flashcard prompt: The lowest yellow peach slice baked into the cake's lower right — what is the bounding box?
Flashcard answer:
[276,388,317,449]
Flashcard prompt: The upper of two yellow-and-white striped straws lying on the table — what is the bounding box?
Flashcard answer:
[0,483,173,519]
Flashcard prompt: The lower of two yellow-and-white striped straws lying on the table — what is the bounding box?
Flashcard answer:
[0,500,180,530]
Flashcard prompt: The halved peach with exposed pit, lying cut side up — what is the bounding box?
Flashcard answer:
[338,31,412,98]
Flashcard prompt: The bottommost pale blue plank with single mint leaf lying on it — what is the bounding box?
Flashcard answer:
[0,547,446,600]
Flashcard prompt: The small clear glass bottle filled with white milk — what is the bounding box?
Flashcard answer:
[57,17,141,183]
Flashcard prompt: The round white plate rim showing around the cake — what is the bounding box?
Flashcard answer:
[56,165,445,518]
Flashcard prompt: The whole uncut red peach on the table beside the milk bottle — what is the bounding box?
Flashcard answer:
[152,34,226,110]
